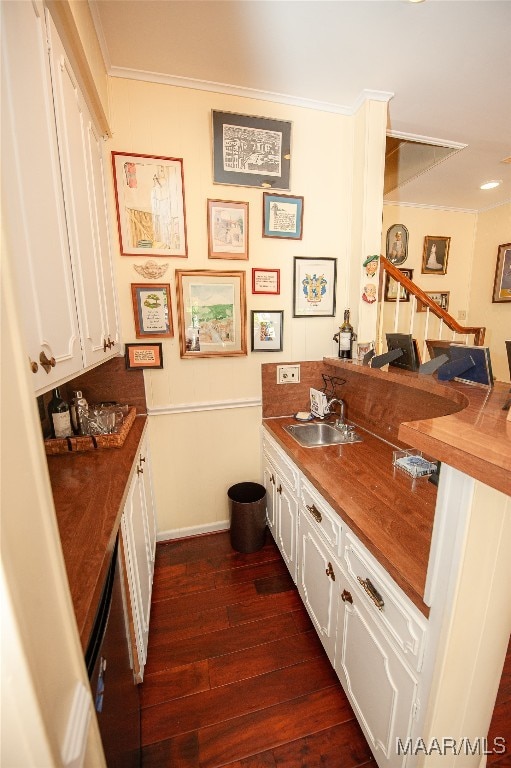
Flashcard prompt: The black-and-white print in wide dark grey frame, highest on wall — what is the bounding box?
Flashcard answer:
[212,110,291,190]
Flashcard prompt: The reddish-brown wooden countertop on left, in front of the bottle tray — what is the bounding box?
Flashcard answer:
[47,416,147,650]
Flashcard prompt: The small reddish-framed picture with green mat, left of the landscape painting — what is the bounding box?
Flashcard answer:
[131,283,174,339]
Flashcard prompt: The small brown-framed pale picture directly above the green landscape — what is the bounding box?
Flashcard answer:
[208,200,248,259]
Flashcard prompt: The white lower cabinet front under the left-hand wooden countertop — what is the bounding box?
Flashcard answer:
[121,428,156,682]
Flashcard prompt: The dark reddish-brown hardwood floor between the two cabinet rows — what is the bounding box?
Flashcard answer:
[141,532,376,768]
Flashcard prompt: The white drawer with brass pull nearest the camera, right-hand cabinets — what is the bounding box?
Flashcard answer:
[344,531,427,671]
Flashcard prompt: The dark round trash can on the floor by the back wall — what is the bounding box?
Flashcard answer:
[227,483,266,554]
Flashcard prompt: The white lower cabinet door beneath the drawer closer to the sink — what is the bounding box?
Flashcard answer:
[298,514,340,664]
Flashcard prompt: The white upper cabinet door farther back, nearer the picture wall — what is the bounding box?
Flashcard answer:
[47,12,120,366]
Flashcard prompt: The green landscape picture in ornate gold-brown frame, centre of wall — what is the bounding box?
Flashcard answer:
[176,269,247,357]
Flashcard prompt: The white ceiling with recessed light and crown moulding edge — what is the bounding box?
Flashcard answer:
[89,0,511,210]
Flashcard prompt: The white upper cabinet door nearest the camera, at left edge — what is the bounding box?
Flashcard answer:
[1,2,83,392]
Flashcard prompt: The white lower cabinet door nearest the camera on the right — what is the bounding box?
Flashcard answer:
[335,574,417,768]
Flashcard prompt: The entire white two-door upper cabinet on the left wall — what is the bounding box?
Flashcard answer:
[2,1,120,394]
